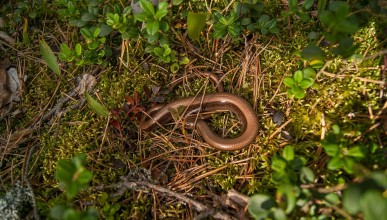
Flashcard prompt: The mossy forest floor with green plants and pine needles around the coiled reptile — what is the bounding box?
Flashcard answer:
[0,0,387,219]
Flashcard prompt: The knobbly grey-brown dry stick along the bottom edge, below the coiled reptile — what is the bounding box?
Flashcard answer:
[112,177,234,219]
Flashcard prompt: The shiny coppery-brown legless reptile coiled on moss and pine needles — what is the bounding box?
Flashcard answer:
[140,73,259,151]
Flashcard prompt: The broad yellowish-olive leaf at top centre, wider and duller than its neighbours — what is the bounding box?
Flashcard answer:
[187,12,207,41]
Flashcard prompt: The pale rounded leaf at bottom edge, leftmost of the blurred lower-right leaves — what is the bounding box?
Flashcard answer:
[248,194,277,219]
